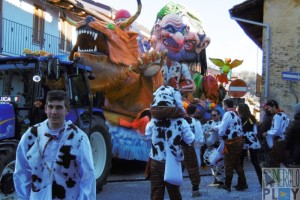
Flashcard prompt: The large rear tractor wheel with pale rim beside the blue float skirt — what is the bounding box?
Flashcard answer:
[89,116,112,192]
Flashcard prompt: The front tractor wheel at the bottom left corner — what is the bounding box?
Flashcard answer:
[0,145,17,200]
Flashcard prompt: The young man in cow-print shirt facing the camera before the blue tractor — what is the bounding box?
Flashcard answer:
[14,90,96,200]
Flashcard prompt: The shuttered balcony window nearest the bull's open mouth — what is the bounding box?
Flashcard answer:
[60,19,72,52]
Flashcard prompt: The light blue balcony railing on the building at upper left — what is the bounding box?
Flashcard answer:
[0,18,71,60]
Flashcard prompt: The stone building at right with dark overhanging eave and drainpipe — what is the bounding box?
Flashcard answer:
[229,0,300,118]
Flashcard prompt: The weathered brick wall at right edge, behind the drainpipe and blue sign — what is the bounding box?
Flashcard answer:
[261,0,300,118]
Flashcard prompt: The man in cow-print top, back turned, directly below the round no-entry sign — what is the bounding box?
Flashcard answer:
[214,99,248,192]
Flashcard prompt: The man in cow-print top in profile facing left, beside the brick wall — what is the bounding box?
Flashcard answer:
[262,100,290,167]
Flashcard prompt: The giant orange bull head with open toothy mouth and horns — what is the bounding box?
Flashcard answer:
[69,0,166,116]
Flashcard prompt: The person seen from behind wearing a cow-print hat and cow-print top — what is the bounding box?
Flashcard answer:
[145,86,195,199]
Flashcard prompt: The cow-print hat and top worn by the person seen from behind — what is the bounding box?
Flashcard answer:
[145,86,195,161]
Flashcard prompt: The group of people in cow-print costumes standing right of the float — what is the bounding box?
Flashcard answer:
[146,83,300,199]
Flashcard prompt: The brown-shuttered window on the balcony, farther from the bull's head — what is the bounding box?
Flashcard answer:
[33,6,45,46]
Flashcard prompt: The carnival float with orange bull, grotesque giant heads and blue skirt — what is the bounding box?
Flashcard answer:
[68,0,223,164]
